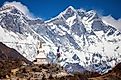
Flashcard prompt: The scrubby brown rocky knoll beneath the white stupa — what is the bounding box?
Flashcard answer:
[6,64,100,80]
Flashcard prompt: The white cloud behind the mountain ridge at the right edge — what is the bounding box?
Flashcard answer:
[102,15,121,31]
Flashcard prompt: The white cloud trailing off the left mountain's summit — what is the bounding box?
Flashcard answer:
[4,1,35,19]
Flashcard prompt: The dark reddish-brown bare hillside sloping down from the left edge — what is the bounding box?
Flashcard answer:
[0,42,31,78]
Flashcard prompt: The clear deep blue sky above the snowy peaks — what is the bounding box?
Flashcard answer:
[0,0,121,20]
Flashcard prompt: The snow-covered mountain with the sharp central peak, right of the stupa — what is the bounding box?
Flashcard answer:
[31,6,121,74]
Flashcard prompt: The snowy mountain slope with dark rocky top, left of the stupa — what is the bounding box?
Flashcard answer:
[0,5,45,61]
